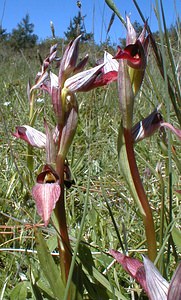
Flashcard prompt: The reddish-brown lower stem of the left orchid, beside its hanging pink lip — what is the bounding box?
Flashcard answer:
[55,155,72,282]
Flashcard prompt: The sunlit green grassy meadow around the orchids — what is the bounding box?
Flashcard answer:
[0,1,181,300]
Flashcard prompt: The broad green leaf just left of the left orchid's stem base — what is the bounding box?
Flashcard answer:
[35,229,65,300]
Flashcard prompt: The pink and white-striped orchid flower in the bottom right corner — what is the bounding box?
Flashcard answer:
[110,250,181,300]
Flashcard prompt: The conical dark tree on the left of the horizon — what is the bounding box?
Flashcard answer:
[9,14,38,50]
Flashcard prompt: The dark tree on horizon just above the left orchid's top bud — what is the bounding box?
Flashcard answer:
[64,11,93,42]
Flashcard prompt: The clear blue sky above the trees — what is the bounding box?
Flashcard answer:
[0,0,181,43]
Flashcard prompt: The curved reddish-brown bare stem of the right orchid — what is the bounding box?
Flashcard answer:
[124,128,157,261]
